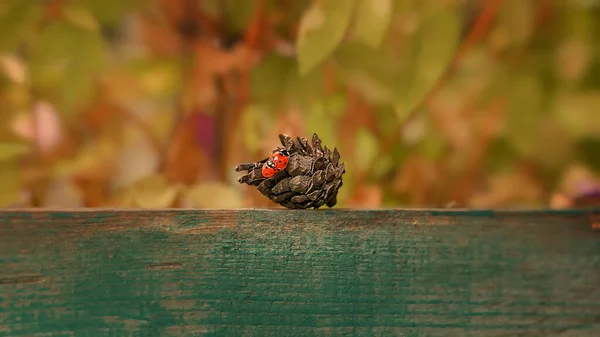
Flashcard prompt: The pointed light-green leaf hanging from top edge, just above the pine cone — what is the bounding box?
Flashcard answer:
[296,0,355,75]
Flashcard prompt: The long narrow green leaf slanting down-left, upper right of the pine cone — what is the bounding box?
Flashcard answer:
[396,10,461,117]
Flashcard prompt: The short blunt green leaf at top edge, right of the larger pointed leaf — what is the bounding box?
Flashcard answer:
[354,0,393,48]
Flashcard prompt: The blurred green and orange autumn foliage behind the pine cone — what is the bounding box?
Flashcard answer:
[0,0,600,208]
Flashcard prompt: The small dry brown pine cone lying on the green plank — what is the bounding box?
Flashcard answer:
[235,133,346,209]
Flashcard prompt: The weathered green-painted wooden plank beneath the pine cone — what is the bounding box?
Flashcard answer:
[0,210,600,337]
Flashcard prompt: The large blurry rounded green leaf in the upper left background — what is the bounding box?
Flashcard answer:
[30,22,108,112]
